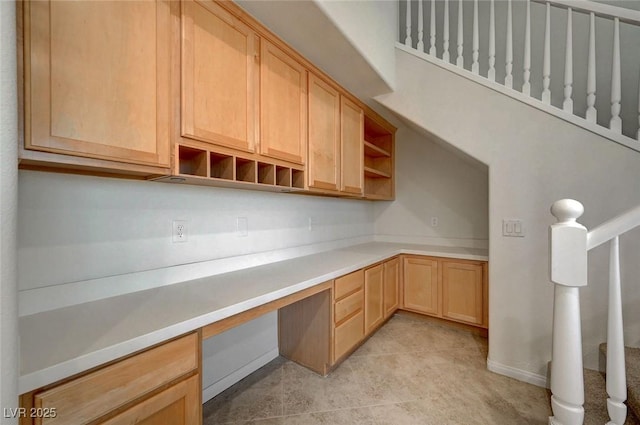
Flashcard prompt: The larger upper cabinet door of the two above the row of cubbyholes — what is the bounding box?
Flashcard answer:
[181,0,258,151]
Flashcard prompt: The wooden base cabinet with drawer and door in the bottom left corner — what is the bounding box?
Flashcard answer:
[21,333,202,425]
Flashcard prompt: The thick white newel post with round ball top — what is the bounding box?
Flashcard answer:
[549,199,587,425]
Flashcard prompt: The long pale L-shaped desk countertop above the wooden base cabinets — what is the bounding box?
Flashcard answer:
[19,242,488,394]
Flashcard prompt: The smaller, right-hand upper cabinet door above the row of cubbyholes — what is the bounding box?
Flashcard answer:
[260,40,307,164]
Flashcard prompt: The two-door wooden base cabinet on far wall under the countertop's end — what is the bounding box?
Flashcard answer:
[403,256,488,328]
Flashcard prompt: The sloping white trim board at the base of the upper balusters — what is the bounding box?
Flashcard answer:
[396,42,640,152]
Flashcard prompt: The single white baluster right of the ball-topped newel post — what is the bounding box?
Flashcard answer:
[607,236,627,425]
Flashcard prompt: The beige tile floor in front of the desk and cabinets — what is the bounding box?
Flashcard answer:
[203,315,551,425]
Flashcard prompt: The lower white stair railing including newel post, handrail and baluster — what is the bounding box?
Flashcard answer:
[549,199,640,425]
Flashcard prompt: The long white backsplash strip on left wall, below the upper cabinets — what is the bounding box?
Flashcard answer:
[18,236,373,317]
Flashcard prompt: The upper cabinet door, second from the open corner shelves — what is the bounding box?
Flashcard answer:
[307,74,340,191]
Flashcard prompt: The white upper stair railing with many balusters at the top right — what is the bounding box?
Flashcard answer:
[398,0,640,151]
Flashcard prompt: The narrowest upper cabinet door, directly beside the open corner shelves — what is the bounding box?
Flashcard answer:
[340,97,364,195]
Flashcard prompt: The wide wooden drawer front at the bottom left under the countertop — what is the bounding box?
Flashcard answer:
[34,334,198,425]
